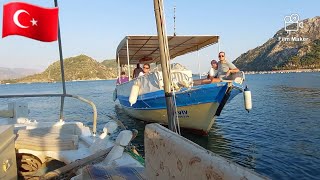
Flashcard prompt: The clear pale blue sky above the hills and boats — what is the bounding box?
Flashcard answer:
[0,0,320,73]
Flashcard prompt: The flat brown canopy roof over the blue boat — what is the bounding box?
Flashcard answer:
[116,35,219,64]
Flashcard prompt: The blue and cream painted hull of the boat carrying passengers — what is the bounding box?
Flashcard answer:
[117,82,241,134]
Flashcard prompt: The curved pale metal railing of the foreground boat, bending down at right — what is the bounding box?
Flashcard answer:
[0,94,98,136]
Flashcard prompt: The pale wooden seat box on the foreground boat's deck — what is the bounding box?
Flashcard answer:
[15,127,79,151]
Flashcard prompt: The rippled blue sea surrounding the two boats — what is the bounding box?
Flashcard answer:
[0,73,320,179]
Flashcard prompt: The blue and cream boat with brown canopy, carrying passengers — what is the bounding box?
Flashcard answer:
[115,36,248,134]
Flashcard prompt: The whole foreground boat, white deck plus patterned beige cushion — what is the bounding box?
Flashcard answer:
[0,103,266,180]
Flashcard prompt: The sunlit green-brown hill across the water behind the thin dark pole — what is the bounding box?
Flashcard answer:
[6,55,117,83]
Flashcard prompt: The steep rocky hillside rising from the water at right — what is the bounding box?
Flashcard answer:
[233,16,320,71]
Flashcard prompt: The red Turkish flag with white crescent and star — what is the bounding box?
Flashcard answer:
[2,2,58,42]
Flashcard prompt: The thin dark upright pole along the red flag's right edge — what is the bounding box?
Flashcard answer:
[54,0,67,121]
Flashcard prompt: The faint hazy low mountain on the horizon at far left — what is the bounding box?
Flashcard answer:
[0,67,40,80]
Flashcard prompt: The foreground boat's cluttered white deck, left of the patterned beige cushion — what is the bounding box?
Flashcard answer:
[0,103,144,179]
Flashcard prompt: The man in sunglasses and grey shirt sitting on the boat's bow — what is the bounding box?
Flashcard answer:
[218,51,239,80]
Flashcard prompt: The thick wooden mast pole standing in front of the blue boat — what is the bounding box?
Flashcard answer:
[153,0,177,132]
